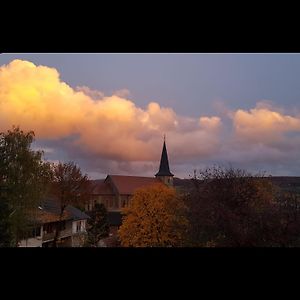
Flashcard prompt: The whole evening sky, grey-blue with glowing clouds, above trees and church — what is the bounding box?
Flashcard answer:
[0,53,300,179]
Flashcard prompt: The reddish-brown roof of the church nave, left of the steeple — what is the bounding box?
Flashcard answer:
[108,175,162,195]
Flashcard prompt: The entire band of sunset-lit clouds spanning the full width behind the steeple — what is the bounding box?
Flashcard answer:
[0,60,300,176]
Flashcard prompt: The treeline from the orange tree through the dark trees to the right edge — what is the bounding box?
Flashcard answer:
[119,167,300,247]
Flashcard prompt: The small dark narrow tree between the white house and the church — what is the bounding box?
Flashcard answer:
[86,203,109,247]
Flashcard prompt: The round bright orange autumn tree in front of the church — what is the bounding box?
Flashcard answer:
[119,184,188,247]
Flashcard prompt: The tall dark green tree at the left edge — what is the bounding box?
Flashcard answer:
[0,127,51,246]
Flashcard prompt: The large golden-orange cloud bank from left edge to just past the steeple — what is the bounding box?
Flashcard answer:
[0,60,222,162]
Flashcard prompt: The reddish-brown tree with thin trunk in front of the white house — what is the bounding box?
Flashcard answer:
[52,162,91,247]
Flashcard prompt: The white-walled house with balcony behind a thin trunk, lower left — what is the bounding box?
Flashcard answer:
[19,199,89,247]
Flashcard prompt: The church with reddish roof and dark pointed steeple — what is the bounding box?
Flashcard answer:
[85,139,182,241]
